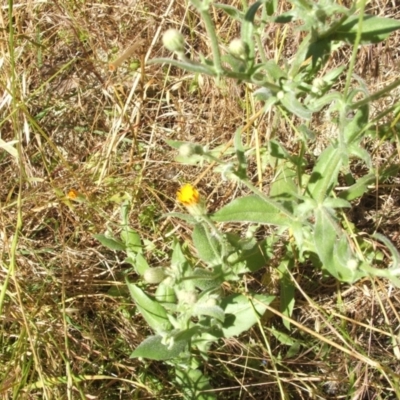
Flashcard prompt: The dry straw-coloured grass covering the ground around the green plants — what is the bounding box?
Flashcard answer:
[0,0,400,400]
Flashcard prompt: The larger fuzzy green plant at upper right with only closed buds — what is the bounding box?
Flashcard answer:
[156,1,400,286]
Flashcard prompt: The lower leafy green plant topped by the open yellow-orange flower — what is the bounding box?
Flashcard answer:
[95,192,274,399]
